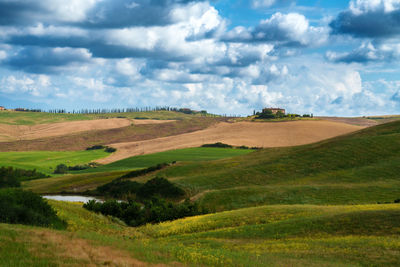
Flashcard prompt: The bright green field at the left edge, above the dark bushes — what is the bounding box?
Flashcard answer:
[0,150,109,174]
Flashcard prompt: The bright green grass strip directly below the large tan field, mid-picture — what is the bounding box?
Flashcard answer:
[78,147,254,173]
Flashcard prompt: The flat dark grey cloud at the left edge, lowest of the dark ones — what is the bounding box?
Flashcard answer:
[4,47,91,73]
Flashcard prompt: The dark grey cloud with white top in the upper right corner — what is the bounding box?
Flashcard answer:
[330,0,400,38]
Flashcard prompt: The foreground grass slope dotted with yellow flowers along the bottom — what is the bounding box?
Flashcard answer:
[0,201,400,266]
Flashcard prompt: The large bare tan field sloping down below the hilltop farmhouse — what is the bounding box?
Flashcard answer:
[98,120,364,164]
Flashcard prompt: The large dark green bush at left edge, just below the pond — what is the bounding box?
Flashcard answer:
[0,188,66,229]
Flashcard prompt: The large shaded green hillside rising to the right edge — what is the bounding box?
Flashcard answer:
[130,121,400,210]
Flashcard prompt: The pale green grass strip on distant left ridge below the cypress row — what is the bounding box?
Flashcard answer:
[0,111,211,125]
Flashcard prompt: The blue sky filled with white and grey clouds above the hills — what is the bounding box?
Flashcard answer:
[0,0,400,116]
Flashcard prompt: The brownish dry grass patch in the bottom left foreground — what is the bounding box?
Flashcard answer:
[28,230,166,267]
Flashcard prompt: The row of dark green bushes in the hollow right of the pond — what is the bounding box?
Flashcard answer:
[83,197,207,226]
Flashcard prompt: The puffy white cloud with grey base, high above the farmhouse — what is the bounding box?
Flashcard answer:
[222,12,328,46]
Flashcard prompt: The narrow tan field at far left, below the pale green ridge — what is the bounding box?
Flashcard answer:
[0,118,173,142]
